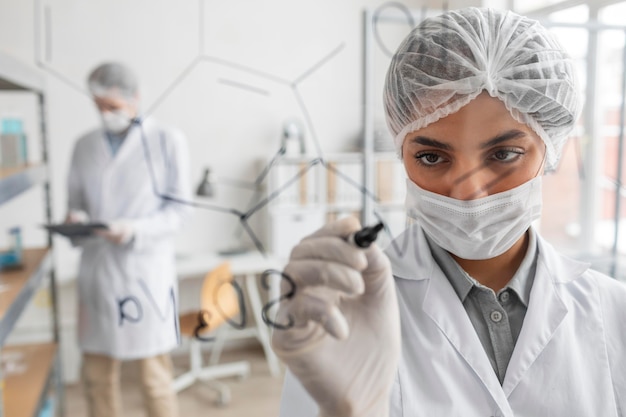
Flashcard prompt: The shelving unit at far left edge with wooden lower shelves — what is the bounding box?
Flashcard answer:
[0,54,63,417]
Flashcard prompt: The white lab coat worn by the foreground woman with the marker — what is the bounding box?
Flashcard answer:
[280,226,626,417]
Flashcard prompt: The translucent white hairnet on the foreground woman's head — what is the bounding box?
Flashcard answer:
[384,8,580,170]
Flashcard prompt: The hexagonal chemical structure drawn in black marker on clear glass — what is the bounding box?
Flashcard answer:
[35,0,424,329]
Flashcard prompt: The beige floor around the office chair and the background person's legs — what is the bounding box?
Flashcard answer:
[65,347,282,417]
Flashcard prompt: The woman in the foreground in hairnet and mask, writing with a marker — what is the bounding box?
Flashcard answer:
[273,8,626,417]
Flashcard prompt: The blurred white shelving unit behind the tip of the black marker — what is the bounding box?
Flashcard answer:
[268,153,405,259]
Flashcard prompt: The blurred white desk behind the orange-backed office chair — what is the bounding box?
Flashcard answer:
[176,251,283,376]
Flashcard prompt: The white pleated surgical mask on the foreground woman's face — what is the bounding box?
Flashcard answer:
[406,176,542,259]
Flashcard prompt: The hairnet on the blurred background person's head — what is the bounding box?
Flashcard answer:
[87,62,139,99]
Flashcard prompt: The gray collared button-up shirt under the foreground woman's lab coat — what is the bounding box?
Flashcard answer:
[426,228,537,384]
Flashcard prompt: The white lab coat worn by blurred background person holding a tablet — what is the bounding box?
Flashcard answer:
[68,119,190,359]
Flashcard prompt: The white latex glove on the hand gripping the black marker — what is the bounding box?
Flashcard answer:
[272,217,400,417]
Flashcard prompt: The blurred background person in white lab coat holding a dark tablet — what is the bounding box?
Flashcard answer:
[68,63,190,417]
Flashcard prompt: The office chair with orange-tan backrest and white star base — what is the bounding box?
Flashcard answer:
[173,262,250,406]
